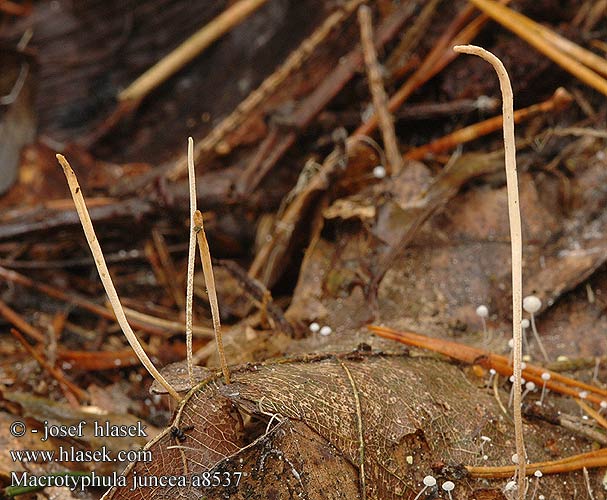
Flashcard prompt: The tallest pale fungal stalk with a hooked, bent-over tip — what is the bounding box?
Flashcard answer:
[453,45,527,500]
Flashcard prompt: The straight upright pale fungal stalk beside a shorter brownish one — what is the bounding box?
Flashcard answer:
[185,137,196,387]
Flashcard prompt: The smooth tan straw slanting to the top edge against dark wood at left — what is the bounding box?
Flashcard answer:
[118,0,267,101]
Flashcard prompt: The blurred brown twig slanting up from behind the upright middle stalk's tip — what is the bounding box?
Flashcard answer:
[168,0,365,180]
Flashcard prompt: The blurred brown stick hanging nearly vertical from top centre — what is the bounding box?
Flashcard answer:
[358,5,403,174]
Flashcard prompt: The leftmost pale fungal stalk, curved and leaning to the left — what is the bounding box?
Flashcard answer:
[57,154,181,401]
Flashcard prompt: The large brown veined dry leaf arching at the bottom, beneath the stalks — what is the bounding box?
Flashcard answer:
[104,346,583,500]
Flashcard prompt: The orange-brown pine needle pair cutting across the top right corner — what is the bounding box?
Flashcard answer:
[471,0,607,95]
